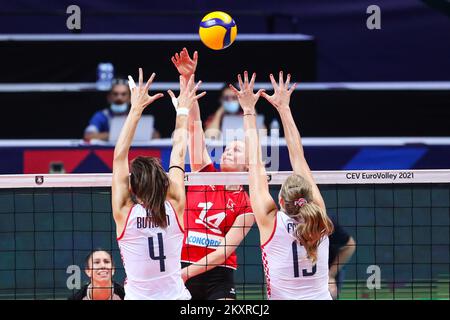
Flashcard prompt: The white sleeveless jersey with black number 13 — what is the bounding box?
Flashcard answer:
[261,211,332,300]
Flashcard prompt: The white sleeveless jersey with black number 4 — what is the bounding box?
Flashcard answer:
[117,201,191,300]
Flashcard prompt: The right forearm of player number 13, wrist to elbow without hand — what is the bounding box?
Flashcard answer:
[279,107,305,171]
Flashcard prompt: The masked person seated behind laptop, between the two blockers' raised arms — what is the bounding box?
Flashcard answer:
[205,85,265,139]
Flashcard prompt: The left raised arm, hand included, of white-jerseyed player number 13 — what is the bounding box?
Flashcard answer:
[230,71,278,230]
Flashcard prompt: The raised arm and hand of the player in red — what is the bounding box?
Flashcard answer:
[171,48,211,172]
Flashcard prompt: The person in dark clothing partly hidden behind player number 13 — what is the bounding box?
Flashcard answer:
[328,216,356,299]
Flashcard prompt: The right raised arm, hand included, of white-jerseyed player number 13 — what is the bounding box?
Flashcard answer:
[262,71,325,209]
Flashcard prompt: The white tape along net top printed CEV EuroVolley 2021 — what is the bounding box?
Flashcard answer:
[0,170,450,189]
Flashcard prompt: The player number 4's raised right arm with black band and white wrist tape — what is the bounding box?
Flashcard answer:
[167,75,206,223]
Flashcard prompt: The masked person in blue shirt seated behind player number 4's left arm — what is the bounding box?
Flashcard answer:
[84,79,160,141]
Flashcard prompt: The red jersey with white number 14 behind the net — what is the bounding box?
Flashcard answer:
[181,163,252,269]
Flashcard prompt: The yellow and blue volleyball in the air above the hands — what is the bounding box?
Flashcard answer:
[198,11,237,50]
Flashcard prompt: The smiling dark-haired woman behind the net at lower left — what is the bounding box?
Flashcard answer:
[69,249,125,300]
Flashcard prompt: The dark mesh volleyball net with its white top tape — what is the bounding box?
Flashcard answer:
[0,170,450,300]
